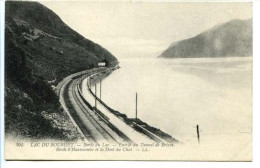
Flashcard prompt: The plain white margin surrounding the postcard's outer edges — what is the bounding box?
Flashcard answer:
[0,0,260,168]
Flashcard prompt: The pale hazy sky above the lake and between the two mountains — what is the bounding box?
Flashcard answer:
[41,1,252,59]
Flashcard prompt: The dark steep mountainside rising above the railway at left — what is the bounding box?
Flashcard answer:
[5,1,118,140]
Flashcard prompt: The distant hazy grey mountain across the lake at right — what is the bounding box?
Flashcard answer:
[159,19,253,58]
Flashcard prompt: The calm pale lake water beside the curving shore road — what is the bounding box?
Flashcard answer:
[94,57,252,150]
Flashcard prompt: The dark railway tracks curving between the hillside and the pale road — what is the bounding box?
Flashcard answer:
[60,71,129,144]
